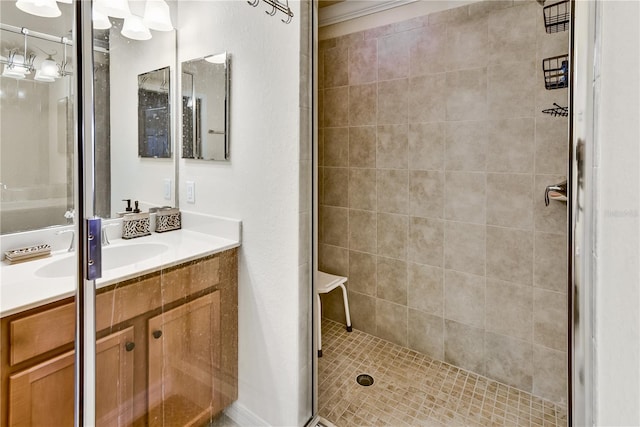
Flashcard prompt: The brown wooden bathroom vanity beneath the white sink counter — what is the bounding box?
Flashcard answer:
[0,224,239,427]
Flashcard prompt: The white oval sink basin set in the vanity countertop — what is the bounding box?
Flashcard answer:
[35,243,169,279]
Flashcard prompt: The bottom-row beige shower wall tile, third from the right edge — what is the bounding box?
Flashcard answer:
[444,320,485,375]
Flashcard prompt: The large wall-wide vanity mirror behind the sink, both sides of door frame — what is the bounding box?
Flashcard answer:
[0,1,180,234]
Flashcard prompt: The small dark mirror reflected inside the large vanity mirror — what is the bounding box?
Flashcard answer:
[138,67,171,158]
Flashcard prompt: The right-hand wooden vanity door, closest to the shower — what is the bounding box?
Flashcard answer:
[148,291,221,427]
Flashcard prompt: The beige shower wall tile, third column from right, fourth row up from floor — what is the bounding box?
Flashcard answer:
[444,172,486,224]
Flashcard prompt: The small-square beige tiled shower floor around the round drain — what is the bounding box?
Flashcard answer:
[318,319,567,427]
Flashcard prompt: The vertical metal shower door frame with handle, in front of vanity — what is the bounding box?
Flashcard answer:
[73,0,102,427]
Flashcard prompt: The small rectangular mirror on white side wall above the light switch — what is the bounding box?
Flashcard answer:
[181,52,230,160]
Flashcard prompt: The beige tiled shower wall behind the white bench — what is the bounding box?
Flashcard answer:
[318,1,569,403]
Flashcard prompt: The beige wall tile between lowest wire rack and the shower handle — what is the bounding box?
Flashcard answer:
[536,117,569,176]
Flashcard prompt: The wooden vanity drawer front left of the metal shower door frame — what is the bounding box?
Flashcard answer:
[9,303,76,365]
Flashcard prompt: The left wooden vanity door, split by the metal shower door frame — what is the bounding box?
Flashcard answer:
[9,327,134,427]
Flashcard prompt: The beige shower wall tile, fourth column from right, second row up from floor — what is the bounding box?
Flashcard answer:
[407,262,444,317]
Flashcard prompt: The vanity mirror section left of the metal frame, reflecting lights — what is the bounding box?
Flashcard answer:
[0,1,73,234]
